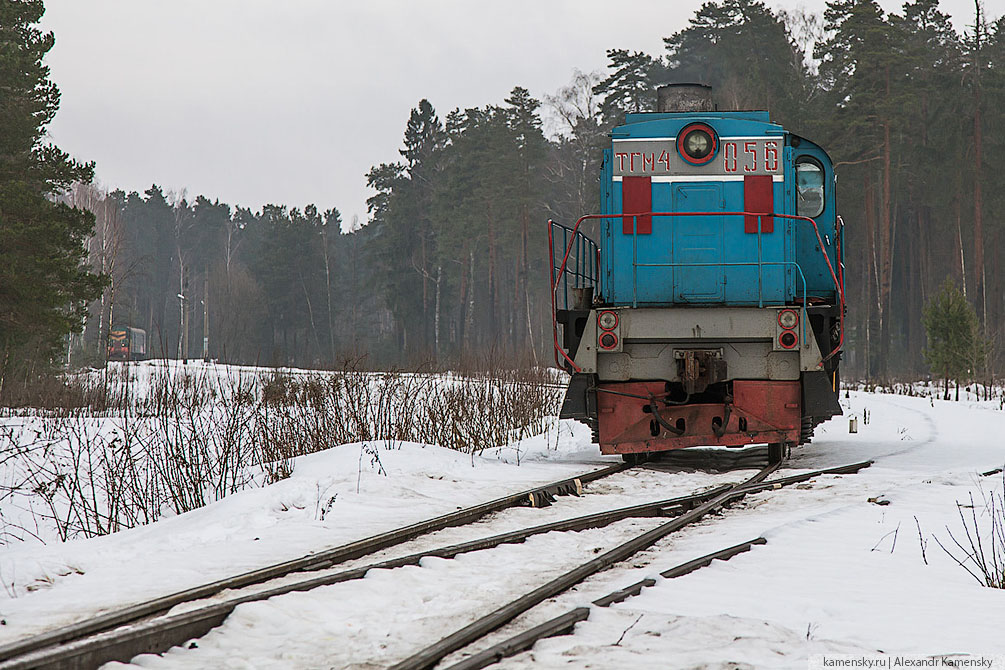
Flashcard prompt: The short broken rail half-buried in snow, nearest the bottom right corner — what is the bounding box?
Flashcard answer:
[445,537,768,670]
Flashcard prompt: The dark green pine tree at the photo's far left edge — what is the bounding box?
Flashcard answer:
[0,0,105,395]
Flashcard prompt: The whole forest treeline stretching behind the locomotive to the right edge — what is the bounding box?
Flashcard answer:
[1,0,1005,385]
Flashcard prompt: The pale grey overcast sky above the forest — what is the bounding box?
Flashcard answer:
[43,0,988,228]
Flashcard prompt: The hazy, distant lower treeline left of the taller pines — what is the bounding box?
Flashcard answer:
[68,184,377,366]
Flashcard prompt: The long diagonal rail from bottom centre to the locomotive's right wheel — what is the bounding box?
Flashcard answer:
[390,461,871,670]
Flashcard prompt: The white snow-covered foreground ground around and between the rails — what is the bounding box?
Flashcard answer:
[0,381,1005,670]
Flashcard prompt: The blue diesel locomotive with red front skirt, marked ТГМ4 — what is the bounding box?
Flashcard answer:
[549,84,844,462]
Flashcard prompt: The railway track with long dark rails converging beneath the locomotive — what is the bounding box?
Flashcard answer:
[0,462,869,670]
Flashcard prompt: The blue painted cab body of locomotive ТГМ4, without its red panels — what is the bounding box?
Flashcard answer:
[599,111,836,305]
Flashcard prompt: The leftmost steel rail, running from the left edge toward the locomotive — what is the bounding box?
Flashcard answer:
[0,463,629,670]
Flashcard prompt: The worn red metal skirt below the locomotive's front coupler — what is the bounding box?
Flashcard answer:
[597,380,801,454]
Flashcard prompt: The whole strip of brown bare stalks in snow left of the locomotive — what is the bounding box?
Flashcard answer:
[0,362,562,545]
